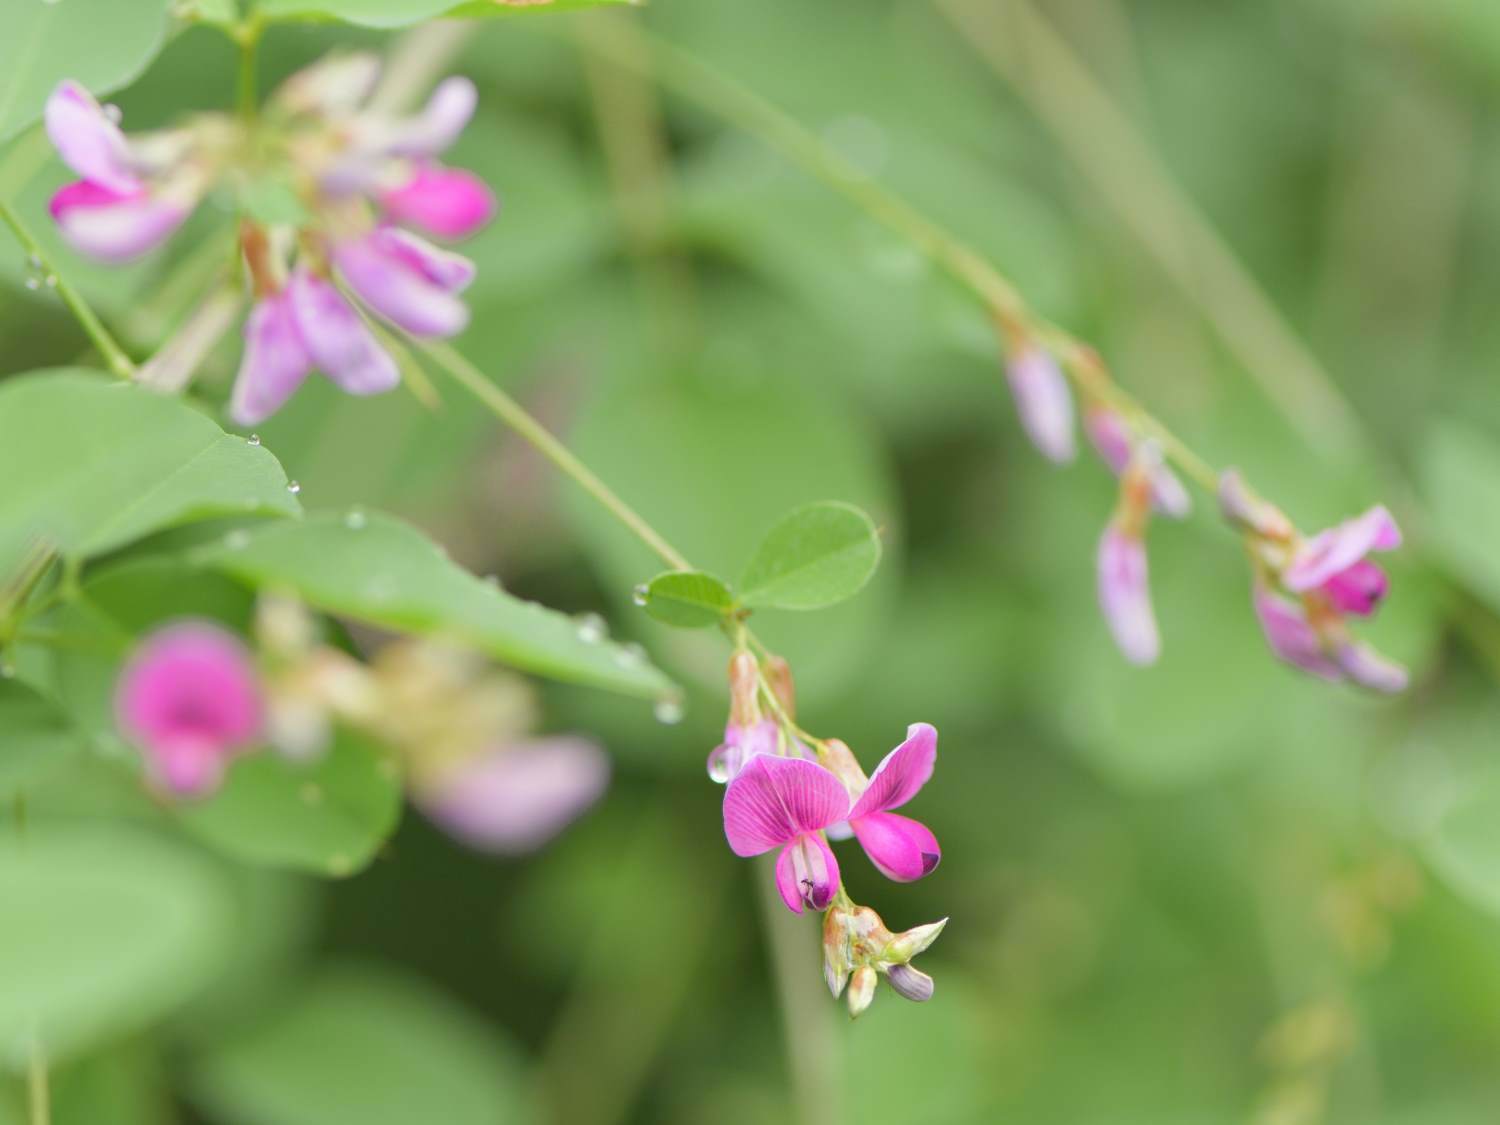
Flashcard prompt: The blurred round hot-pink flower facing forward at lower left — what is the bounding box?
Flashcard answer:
[116,621,263,795]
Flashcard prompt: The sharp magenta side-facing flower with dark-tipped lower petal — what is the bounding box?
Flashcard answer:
[846,723,942,884]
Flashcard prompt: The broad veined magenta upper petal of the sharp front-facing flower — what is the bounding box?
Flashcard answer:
[725,755,849,855]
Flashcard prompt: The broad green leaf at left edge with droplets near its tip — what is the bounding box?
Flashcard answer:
[0,369,300,572]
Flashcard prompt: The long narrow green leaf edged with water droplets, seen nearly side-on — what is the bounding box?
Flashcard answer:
[192,513,672,698]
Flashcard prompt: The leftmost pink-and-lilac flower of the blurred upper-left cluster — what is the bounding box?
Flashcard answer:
[45,81,203,263]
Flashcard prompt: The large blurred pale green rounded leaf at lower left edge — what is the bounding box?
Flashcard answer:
[0,822,233,1062]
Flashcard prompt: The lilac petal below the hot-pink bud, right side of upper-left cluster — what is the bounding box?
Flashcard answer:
[333,228,474,336]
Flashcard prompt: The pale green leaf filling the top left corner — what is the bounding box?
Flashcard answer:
[0,0,171,143]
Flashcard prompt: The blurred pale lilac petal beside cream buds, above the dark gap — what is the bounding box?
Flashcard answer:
[420,735,609,855]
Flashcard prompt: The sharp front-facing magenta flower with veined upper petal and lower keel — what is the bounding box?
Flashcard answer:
[725,755,849,914]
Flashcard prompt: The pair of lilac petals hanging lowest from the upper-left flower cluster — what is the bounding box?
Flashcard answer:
[230,267,401,426]
